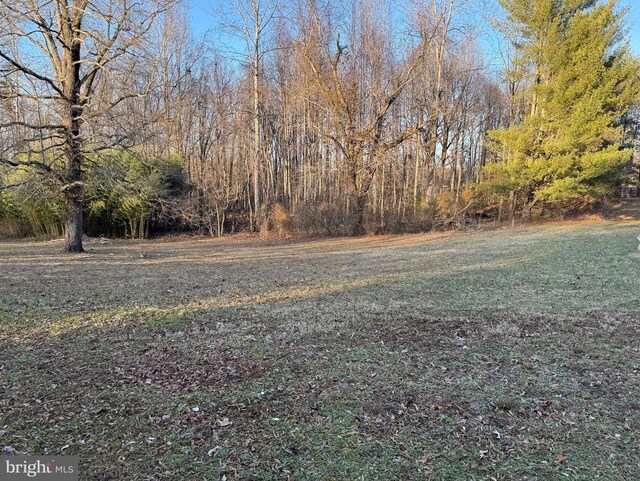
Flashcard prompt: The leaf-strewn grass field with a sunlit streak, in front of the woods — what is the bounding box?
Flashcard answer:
[0,215,640,481]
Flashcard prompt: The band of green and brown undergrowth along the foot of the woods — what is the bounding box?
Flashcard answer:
[0,156,524,239]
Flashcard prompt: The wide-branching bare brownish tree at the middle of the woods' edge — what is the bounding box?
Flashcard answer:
[301,1,426,235]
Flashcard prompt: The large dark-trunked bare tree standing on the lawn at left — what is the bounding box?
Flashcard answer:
[0,0,168,252]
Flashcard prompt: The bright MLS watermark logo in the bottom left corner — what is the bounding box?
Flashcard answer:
[0,456,78,481]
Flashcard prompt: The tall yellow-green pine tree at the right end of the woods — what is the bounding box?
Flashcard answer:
[487,0,640,214]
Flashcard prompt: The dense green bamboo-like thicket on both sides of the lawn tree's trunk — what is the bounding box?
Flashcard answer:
[0,151,189,238]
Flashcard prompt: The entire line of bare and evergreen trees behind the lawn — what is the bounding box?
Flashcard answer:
[0,0,640,250]
